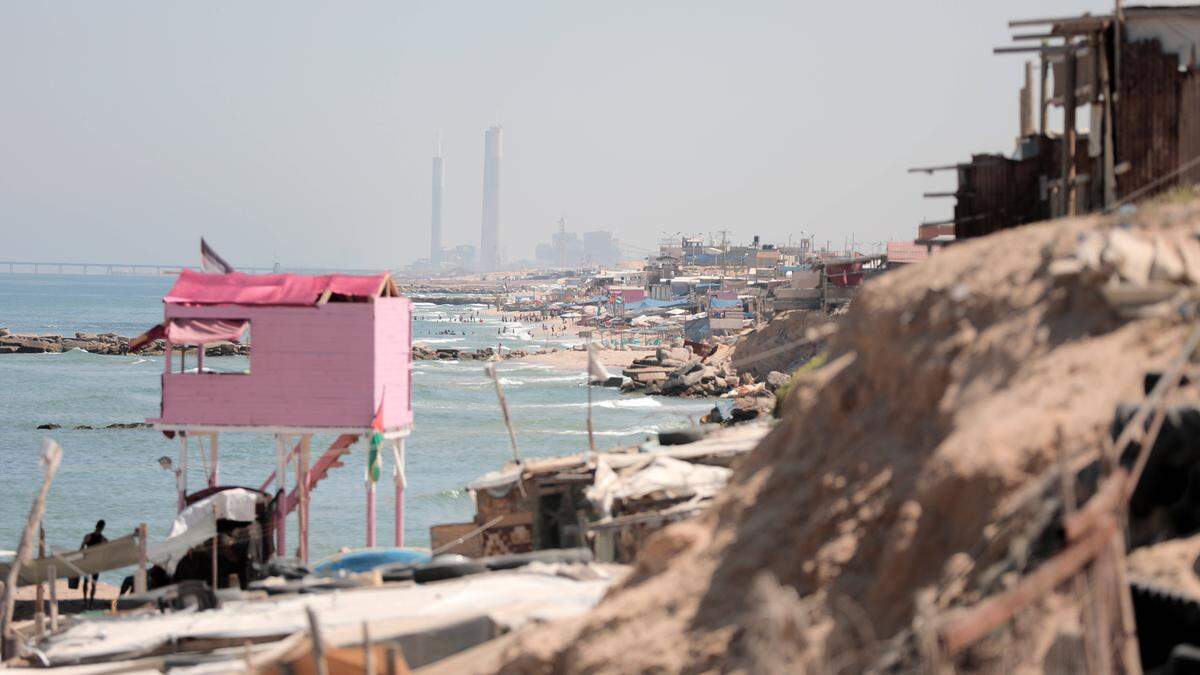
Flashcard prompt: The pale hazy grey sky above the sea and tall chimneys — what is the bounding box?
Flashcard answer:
[0,0,1161,268]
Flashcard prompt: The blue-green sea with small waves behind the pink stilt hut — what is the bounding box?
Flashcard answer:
[0,274,713,571]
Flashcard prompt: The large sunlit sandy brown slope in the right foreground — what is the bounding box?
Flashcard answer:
[486,202,1200,673]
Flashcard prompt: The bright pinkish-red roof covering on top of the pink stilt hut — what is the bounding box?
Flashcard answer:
[163,269,389,305]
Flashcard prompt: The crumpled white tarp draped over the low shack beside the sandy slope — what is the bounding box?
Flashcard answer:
[586,455,733,516]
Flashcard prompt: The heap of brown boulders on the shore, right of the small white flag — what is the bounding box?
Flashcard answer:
[620,345,738,399]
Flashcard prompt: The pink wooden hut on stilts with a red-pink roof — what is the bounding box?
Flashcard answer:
[131,270,413,560]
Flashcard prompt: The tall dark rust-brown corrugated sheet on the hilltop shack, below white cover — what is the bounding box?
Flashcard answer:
[1115,40,1180,198]
